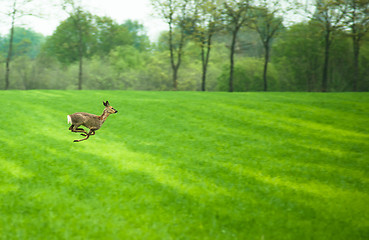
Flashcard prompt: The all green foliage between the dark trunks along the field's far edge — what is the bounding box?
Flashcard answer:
[0,0,369,91]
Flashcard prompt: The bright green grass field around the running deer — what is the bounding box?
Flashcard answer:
[0,91,369,240]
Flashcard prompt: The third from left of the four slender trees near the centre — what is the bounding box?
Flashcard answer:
[224,0,251,92]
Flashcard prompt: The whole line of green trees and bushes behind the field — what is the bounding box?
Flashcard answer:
[0,0,369,92]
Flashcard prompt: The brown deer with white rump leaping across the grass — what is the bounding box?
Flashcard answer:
[67,101,118,142]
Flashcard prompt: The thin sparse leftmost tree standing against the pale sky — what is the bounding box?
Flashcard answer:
[0,0,39,90]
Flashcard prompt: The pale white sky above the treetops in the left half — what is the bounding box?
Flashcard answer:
[0,0,168,41]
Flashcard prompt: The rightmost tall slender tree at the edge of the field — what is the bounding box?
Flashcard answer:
[345,0,369,91]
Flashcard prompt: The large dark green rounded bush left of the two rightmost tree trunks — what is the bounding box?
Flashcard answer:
[273,23,323,91]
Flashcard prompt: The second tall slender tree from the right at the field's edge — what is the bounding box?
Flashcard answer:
[312,0,346,92]
